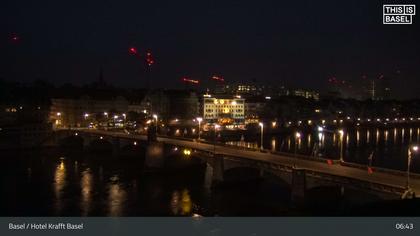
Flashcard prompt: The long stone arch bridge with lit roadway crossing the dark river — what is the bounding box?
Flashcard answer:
[50,129,420,198]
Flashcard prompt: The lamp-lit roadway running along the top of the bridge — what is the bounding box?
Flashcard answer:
[74,130,420,193]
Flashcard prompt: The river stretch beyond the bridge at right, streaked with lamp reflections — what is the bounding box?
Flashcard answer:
[226,127,420,172]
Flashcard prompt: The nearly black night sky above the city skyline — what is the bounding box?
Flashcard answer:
[0,0,420,97]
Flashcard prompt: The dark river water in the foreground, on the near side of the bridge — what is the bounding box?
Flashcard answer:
[0,150,390,216]
